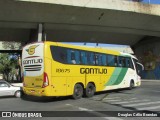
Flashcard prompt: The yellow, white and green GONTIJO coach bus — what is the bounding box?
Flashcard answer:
[22,41,143,99]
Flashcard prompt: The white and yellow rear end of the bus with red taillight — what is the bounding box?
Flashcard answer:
[22,42,50,96]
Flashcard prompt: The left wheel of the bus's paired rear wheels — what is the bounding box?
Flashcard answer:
[72,84,83,99]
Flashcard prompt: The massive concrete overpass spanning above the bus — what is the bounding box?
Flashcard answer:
[0,0,160,45]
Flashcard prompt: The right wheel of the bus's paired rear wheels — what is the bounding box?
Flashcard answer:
[85,83,95,97]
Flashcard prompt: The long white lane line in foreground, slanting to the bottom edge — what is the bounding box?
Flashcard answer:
[66,104,124,120]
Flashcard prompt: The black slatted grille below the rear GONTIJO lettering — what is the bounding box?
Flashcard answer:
[24,65,42,71]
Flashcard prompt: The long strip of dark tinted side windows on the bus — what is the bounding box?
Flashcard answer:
[51,46,134,69]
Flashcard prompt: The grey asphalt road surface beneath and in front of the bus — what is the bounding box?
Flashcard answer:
[0,81,160,120]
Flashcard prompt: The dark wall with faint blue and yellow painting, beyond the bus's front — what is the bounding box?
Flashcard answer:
[135,37,160,80]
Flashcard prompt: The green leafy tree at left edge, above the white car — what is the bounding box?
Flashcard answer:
[0,53,17,81]
